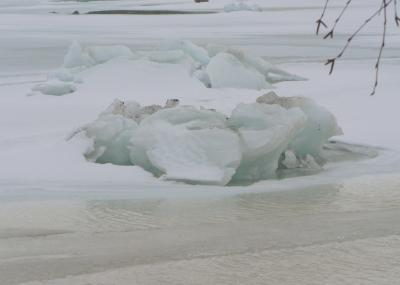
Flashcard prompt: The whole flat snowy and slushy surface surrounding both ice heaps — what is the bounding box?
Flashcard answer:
[0,0,400,285]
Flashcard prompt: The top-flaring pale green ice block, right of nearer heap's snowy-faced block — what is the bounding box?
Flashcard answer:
[229,103,306,181]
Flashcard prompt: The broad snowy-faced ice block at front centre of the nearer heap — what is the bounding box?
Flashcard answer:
[130,121,241,185]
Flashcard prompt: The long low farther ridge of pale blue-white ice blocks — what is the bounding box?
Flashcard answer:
[33,40,304,95]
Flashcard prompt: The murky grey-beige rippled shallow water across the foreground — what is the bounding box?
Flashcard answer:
[0,175,400,285]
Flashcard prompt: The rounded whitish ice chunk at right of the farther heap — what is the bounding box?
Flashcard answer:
[206,53,272,90]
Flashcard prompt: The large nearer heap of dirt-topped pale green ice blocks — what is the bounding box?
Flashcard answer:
[76,93,340,185]
